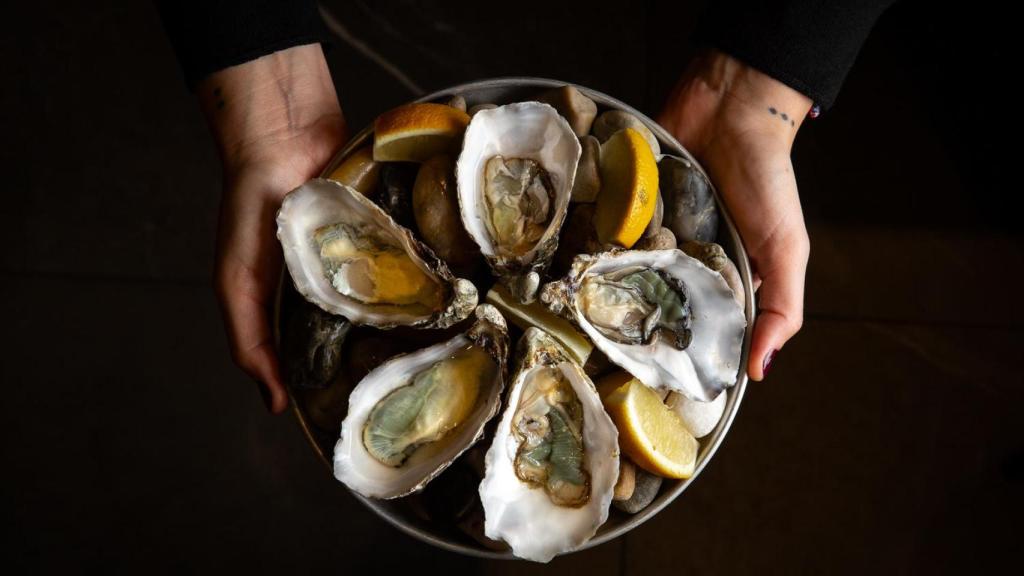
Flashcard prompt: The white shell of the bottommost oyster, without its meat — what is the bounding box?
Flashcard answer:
[479,328,620,562]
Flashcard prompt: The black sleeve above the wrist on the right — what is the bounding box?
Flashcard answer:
[694,0,894,112]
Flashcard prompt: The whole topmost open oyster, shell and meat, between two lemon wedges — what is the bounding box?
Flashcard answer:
[456,101,583,302]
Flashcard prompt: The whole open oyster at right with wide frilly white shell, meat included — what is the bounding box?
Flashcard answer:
[541,249,746,402]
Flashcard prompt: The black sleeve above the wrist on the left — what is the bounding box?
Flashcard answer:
[156,0,328,90]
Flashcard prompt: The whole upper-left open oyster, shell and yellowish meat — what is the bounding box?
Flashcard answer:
[278,178,477,328]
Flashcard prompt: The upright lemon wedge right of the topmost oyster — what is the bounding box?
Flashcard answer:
[594,128,657,248]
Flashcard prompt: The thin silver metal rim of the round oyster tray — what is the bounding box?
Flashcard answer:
[273,76,756,560]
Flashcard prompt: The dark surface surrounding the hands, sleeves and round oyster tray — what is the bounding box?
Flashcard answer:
[0,0,1024,576]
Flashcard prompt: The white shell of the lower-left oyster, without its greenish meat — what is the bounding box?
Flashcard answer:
[334,304,508,499]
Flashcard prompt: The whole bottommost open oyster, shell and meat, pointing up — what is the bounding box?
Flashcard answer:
[479,328,620,562]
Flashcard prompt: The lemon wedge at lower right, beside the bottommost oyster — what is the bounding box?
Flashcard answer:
[598,373,699,478]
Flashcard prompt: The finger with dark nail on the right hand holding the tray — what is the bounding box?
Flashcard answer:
[748,230,808,380]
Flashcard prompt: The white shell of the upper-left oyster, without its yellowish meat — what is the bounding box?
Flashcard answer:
[278,178,477,328]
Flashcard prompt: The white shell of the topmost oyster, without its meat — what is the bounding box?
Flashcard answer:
[456,101,583,289]
